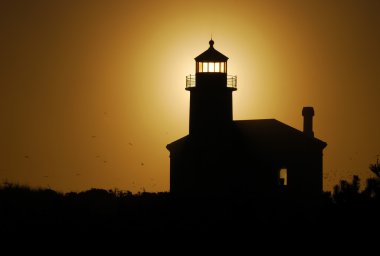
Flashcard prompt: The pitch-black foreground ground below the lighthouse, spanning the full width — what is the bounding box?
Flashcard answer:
[0,184,380,252]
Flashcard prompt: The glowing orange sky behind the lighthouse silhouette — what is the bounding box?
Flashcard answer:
[0,0,380,192]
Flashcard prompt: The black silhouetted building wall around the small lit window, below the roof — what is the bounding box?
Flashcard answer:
[170,141,323,198]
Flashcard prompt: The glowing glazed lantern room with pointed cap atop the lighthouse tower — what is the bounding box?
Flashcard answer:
[195,39,228,74]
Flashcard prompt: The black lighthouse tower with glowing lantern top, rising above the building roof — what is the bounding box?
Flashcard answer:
[186,39,236,135]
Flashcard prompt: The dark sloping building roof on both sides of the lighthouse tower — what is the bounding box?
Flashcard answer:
[166,119,327,152]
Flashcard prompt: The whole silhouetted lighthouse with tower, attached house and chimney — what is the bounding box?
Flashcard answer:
[166,40,327,198]
